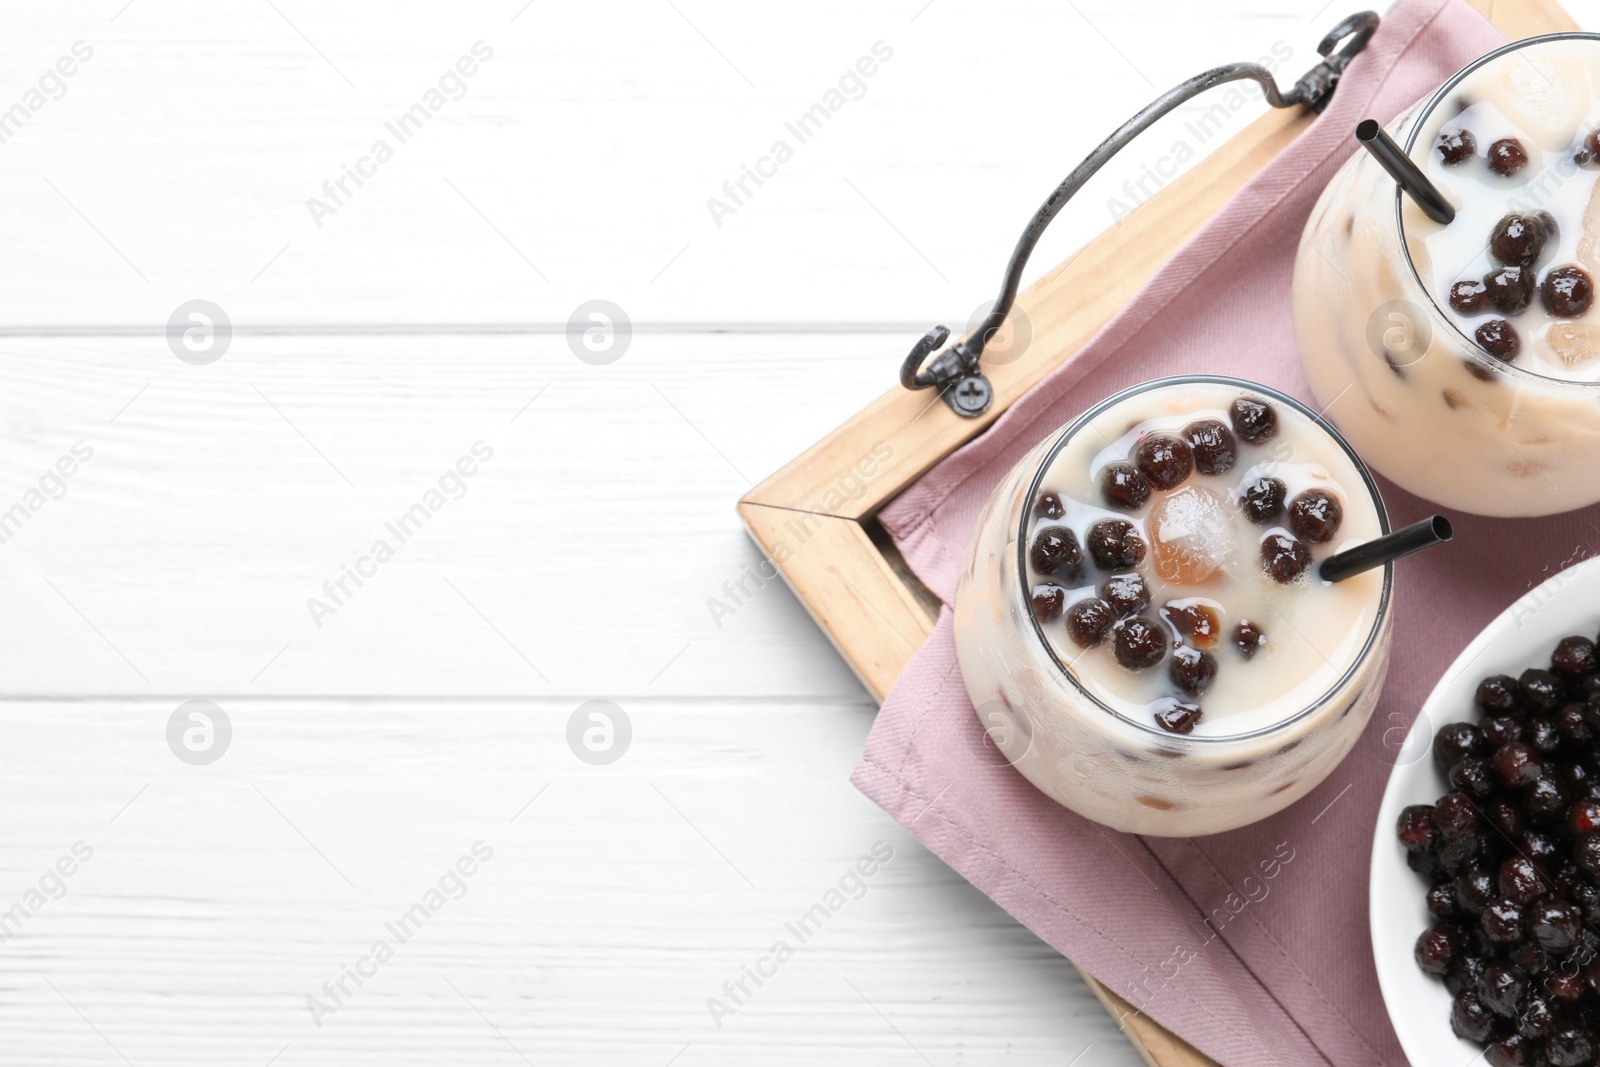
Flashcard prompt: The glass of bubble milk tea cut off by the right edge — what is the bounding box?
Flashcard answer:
[1294,34,1600,517]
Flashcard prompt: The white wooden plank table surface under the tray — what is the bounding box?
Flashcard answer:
[0,0,1600,1067]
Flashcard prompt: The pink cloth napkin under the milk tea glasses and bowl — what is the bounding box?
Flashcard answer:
[853,0,1548,1067]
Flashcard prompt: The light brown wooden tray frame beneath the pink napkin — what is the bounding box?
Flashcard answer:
[739,0,1578,1067]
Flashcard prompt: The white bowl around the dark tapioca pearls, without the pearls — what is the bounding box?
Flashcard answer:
[1368,557,1600,1064]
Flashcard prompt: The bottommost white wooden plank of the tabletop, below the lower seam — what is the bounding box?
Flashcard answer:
[0,697,1134,1067]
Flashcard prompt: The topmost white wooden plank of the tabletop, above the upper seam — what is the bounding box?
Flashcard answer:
[0,0,1459,328]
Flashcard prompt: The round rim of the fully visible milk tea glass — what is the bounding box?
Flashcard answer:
[1016,374,1394,745]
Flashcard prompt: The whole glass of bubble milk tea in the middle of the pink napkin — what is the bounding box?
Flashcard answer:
[955,376,1401,837]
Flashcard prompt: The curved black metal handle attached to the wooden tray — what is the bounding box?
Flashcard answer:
[901,11,1378,418]
